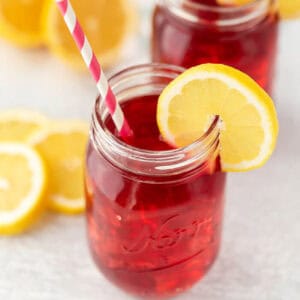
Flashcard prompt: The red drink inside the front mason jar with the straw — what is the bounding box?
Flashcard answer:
[86,96,226,296]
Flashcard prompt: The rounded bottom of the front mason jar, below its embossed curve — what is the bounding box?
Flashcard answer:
[90,245,219,300]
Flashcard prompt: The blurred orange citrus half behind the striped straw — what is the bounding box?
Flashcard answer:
[43,0,135,67]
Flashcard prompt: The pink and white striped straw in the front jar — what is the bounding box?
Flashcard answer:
[55,0,132,138]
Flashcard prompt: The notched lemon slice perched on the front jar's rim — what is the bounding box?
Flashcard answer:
[157,64,278,171]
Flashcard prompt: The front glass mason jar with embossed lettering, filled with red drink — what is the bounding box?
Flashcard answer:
[85,64,226,296]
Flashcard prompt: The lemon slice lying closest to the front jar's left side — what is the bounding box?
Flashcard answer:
[30,121,88,214]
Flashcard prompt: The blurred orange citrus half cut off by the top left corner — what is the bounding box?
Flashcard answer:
[0,0,44,47]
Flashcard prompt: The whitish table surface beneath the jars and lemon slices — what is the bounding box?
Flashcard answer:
[0,1,300,300]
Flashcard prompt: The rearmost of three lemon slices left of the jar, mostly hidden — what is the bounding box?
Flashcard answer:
[0,110,47,142]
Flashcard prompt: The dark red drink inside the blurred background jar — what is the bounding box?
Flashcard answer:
[152,0,278,93]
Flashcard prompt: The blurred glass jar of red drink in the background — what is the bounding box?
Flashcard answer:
[152,0,278,93]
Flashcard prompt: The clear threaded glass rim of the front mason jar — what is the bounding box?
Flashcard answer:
[91,63,220,175]
